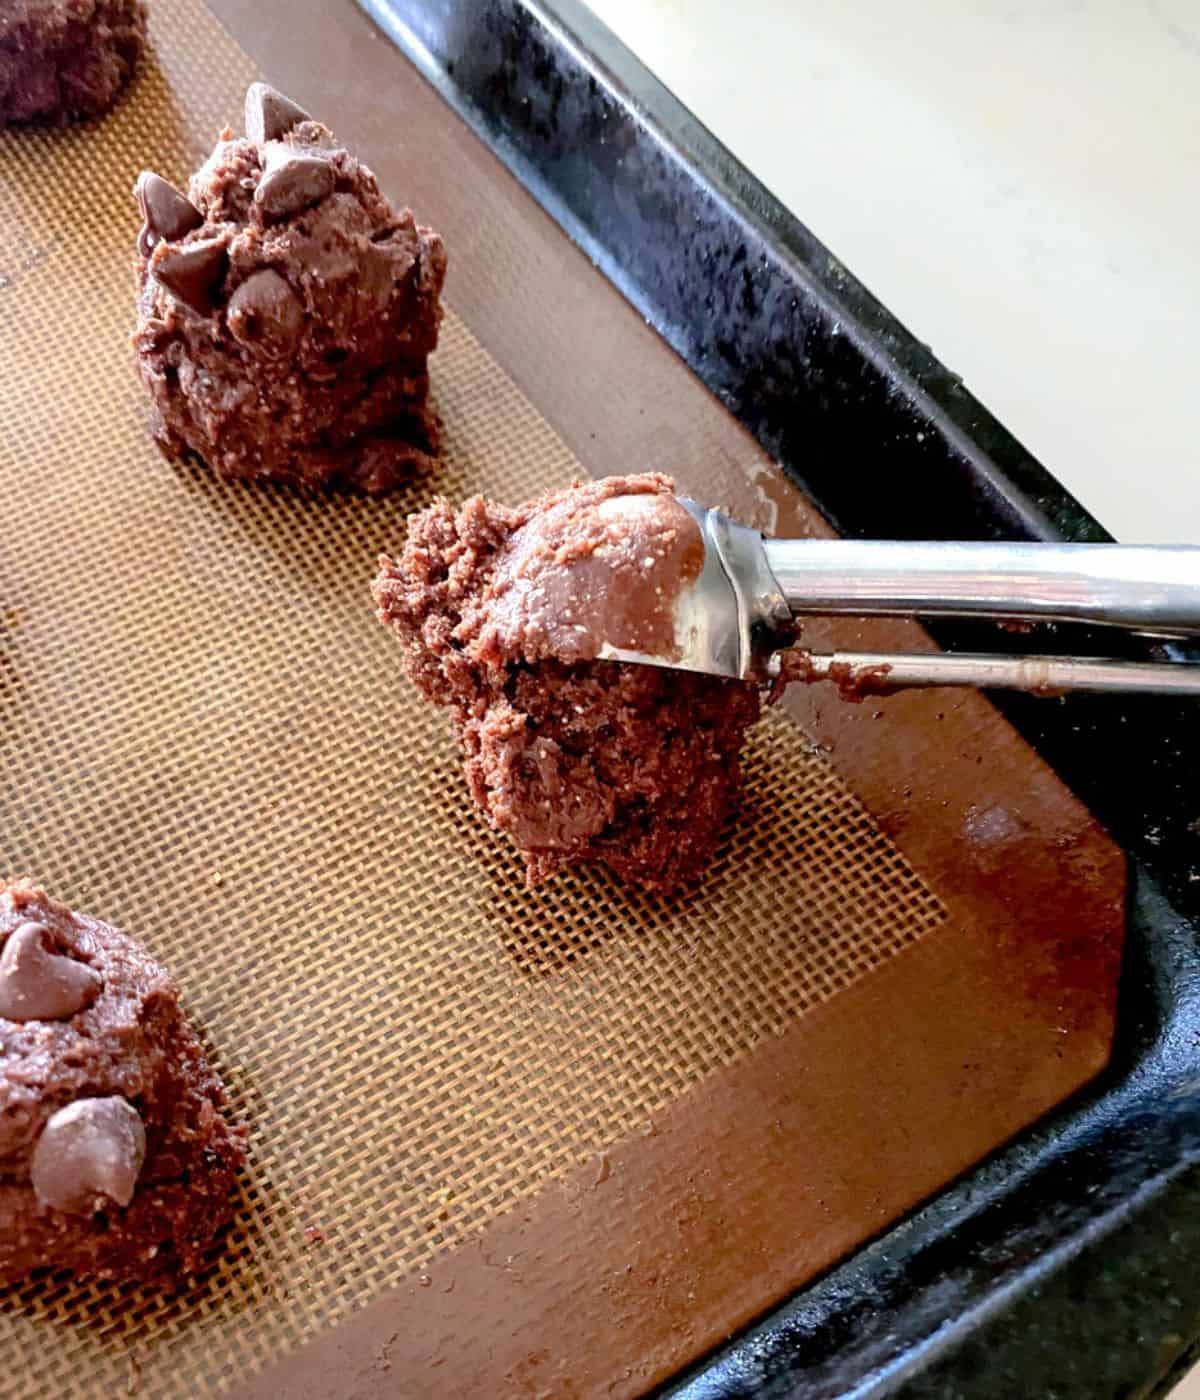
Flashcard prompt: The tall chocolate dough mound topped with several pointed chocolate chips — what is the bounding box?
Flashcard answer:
[134,83,445,493]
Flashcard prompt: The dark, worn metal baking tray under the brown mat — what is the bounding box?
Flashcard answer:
[360,0,1200,1397]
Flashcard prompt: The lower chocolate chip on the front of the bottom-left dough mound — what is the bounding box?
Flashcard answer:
[29,1096,146,1215]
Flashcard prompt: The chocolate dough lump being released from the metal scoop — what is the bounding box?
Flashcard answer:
[374,476,759,889]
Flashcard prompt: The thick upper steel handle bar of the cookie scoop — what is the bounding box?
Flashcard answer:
[763,539,1200,636]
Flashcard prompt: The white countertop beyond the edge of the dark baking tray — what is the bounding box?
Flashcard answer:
[591,0,1200,543]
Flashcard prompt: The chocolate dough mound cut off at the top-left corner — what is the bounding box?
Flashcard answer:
[0,0,146,127]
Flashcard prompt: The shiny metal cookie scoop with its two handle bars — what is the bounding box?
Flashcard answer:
[599,497,1200,694]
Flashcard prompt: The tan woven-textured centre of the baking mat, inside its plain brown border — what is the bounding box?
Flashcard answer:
[0,0,944,1397]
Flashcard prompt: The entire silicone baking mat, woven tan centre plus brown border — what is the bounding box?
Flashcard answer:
[0,0,1123,1397]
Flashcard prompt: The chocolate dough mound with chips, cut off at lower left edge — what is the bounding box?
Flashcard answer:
[0,882,245,1282]
